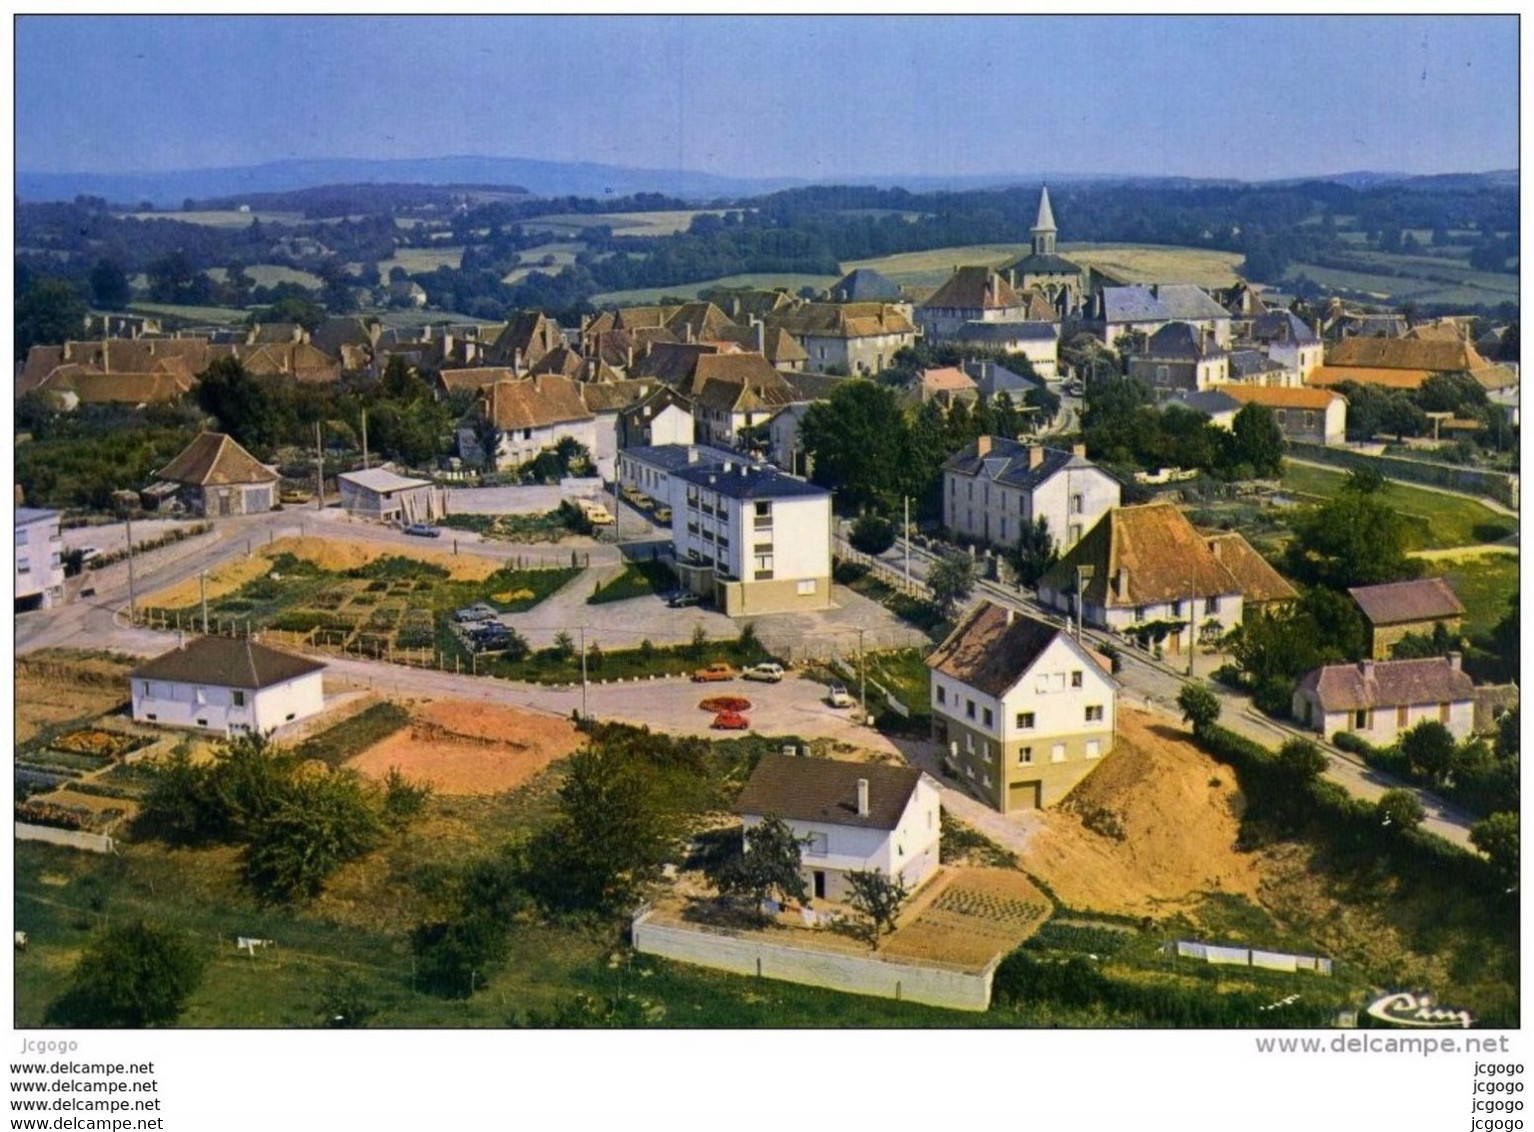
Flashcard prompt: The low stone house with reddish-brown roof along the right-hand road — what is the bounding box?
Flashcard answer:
[1292,652,1476,747]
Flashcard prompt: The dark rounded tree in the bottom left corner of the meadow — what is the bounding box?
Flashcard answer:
[48,920,204,1029]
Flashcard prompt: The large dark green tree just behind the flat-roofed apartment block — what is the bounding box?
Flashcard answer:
[799,380,907,511]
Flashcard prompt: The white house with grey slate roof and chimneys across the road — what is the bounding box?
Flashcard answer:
[943,436,1120,552]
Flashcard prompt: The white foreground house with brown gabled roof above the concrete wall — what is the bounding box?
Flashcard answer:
[735,755,942,900]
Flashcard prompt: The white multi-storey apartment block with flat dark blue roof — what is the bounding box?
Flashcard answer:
[670,457,831,617]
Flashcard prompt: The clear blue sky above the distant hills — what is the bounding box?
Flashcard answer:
[15,17,1519,179]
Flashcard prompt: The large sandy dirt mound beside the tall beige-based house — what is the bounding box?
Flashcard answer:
[1023,707,1259,916]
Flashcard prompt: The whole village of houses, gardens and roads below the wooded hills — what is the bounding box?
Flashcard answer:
[15,180,1519,1026]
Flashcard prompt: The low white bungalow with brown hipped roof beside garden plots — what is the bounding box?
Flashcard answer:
[129,637,325,735]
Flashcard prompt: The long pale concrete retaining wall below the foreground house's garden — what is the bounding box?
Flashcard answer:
[632,913,996,1011]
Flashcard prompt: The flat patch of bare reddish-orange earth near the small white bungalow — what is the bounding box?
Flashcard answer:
[347,699,581,795]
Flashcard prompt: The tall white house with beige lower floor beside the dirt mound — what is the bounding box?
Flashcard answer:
[927,601,1118,813]
